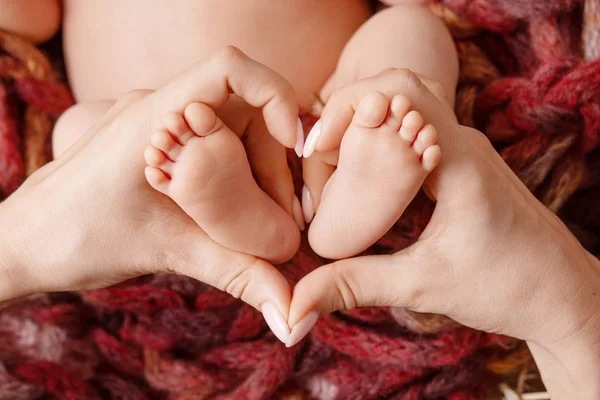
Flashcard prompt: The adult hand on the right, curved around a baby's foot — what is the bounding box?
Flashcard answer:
[288,70,600,399]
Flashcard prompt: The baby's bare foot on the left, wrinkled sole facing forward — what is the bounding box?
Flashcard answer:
[144,103,300,263]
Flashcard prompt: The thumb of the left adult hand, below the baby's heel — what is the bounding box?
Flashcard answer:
[169,228,291,343]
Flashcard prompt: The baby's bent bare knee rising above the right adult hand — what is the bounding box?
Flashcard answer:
[321,5,458,106]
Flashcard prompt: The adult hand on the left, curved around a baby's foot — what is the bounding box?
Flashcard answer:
[0,47,300,341]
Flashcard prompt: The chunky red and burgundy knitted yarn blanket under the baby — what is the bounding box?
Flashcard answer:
[0,0,600,400]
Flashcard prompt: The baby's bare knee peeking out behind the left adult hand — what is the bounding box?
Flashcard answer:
[52,101,114,158]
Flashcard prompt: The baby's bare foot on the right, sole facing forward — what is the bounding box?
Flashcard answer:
[308,92,441,259]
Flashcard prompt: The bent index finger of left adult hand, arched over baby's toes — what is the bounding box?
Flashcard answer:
[149,46,304,151]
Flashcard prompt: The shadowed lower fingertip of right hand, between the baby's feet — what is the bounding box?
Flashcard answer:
[302,153,335,223]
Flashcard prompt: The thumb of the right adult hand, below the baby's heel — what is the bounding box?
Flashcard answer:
[286,244,433,347]
